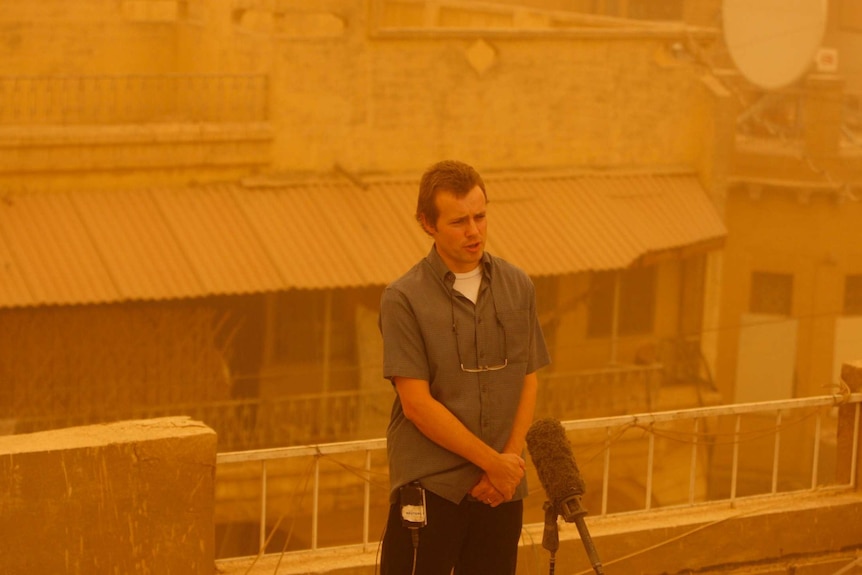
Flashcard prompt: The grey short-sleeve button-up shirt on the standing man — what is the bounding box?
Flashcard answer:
[380,247,550,503]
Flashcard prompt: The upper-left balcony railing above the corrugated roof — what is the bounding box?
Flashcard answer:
[0,74,268,126]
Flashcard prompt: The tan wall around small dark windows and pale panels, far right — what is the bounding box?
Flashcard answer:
[717,186,862,398]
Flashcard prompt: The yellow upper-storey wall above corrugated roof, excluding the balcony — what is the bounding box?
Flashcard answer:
[0,0,706,185]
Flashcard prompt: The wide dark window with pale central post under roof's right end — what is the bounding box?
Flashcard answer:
[587,267,656,337]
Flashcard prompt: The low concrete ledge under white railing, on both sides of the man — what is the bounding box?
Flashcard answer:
[218,492,862,575]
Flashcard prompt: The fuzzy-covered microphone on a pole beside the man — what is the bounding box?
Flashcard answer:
[527,418,604,575]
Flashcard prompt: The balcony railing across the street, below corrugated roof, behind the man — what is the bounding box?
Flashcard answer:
[10,364,663,451]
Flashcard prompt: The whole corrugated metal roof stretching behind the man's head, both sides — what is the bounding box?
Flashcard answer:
[0,174,726,307]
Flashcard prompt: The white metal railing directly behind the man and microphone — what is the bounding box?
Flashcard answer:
[217,393,862,559]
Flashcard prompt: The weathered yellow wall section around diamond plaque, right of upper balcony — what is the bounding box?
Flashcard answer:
[264,33,700,171]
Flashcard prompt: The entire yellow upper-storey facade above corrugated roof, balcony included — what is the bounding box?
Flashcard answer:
[0,0,709,188]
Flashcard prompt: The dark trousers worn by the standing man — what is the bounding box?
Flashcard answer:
[380,492,524,575]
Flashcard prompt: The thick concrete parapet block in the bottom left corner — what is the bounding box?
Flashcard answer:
[0,417,216,575]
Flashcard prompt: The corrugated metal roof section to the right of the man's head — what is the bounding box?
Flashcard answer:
[488,175,726,276]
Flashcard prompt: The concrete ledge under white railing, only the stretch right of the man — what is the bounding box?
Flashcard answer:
[548,492,862,575]
